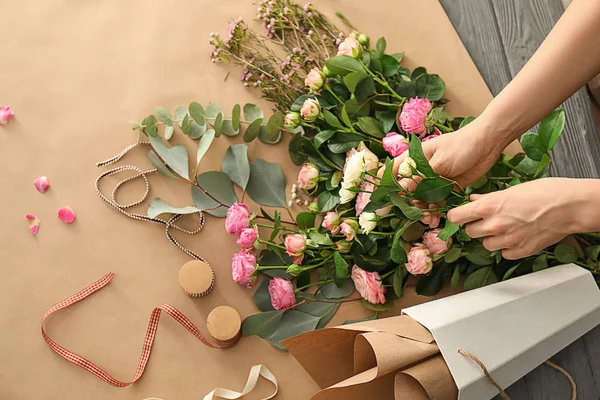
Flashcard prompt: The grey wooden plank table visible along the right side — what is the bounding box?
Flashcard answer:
[440,0,600,400]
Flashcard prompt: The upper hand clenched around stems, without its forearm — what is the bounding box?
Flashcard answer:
[394,117,508,187]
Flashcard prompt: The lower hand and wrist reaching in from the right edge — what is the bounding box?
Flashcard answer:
[448,178,598,259]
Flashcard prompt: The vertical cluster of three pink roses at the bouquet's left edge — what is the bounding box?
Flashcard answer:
[225,202,258,288]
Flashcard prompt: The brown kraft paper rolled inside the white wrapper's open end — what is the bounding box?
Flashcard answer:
[283,315,458,400]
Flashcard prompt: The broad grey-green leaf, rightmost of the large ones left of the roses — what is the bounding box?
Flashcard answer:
[246,158,285,207]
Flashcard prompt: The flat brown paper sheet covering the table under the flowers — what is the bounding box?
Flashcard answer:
[0,0,491,400]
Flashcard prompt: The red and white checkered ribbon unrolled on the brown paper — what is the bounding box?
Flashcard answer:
[42,272,225,387]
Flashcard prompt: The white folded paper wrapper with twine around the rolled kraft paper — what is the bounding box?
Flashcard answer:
[403,264,600,400]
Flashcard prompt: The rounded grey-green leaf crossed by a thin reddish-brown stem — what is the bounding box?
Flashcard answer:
[192,171,237,217]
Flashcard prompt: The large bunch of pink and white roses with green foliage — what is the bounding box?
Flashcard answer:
[123,0,600,347]
